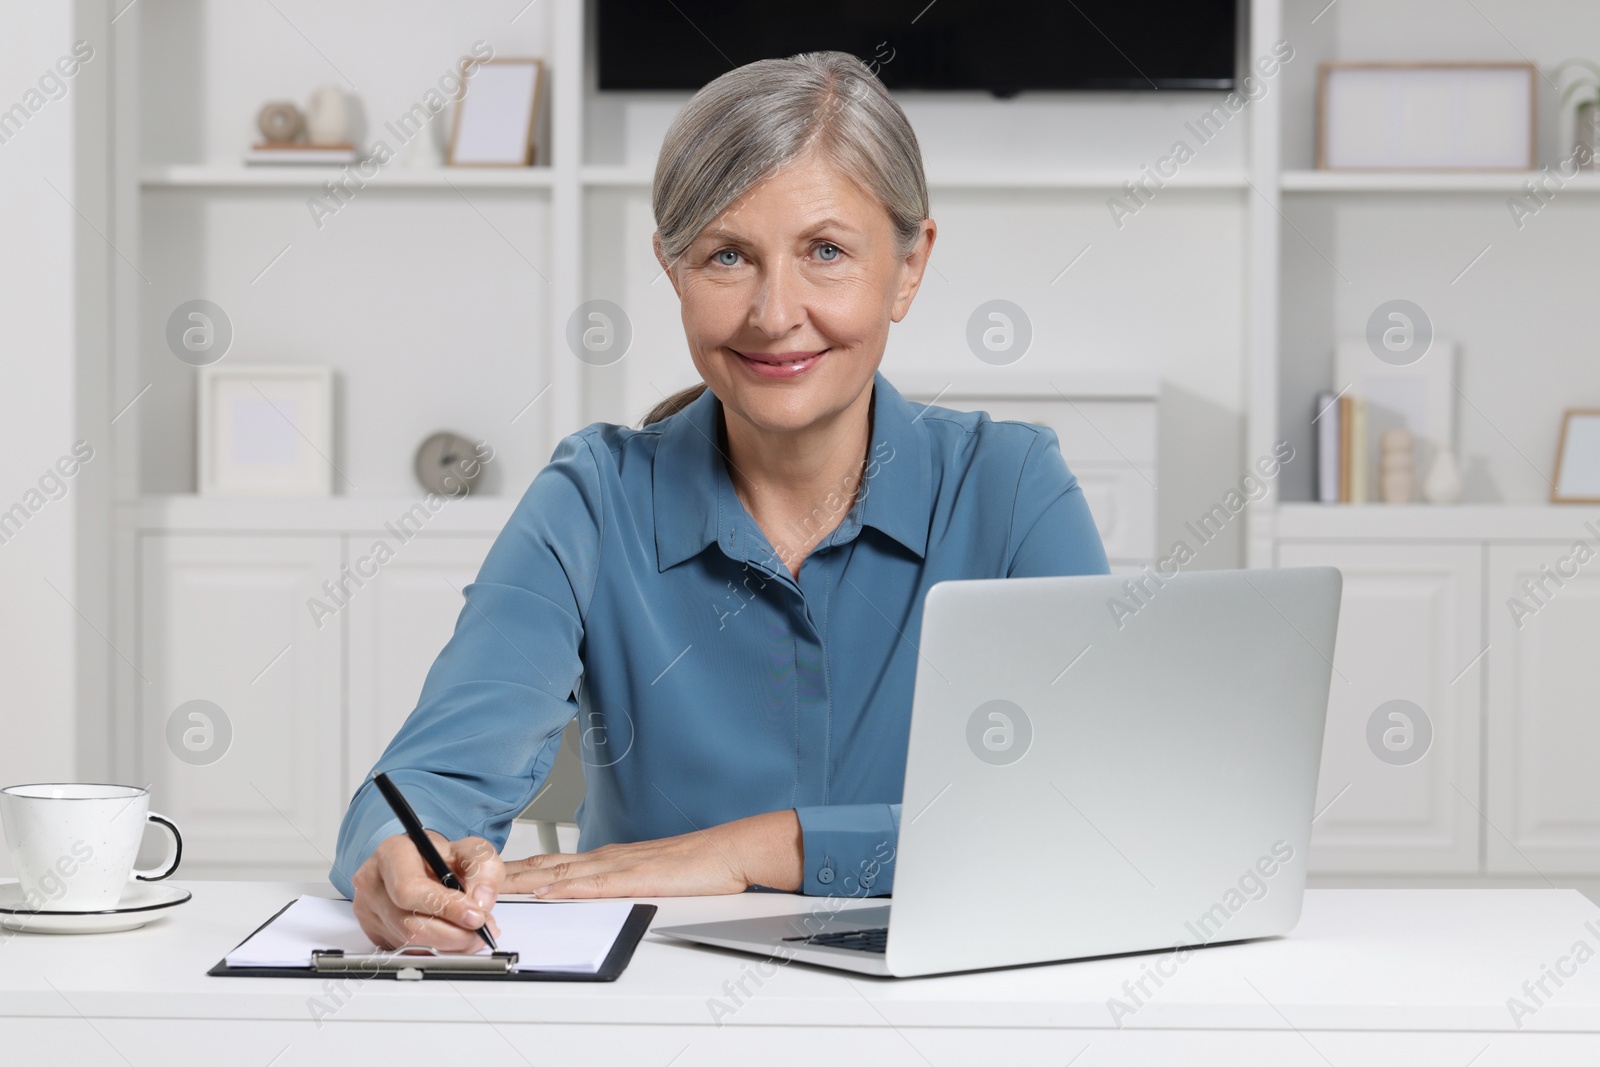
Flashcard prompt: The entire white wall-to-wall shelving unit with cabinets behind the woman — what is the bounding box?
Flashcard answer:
[86,0,1600,875]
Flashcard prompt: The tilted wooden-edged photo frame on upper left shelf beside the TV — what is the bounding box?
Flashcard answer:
[448,59,544,166]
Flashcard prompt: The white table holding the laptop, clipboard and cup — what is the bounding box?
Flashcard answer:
[0,881,1600,1067]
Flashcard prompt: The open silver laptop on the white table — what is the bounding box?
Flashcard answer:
[656,568,1341,976]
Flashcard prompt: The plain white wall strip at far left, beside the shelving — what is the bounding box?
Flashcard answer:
[0,0,110,870]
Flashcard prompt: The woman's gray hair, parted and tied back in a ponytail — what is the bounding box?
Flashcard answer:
[643,51,928,426]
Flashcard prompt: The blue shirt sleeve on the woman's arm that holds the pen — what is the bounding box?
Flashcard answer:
[328,435,605,896]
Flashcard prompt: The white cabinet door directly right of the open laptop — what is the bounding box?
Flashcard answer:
[1278,542,1483,872]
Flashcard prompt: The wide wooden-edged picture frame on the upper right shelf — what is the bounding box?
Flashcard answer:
[1317,62,1538,171]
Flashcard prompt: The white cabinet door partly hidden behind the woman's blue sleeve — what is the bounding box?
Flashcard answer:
[344,534,494,800]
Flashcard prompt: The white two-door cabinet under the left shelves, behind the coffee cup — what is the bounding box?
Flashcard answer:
[136,531,494,880]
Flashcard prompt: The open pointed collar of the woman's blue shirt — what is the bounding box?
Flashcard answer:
[653,371,933,571]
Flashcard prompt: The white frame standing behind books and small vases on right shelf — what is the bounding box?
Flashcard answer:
[1333,338,1456,486]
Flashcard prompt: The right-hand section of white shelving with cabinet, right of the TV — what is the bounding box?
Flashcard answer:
[1246,0,1600,885]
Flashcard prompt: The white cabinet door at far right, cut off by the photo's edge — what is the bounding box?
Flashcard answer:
[1485,537,1600,875]
